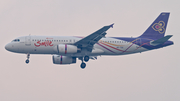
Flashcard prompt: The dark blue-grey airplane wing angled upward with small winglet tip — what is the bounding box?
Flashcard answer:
[74,24,114,51]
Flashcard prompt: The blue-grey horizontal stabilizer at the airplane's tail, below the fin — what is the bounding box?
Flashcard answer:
[150,35,172,46]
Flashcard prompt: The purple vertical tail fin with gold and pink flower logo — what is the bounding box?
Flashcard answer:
[140,12,170,39]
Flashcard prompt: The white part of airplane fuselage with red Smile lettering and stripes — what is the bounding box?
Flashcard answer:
[6,36,148,57]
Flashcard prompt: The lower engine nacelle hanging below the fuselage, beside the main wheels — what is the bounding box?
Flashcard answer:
[52,55,76,64]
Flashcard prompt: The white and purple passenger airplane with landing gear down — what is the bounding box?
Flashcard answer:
[5,12,174,69]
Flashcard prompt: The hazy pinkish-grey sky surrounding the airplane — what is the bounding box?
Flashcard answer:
[0,0,180,101]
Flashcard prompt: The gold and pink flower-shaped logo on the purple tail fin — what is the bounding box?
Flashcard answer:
[152,21,165,34]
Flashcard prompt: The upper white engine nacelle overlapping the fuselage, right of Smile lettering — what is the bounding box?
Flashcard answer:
[54,44,78,54]
